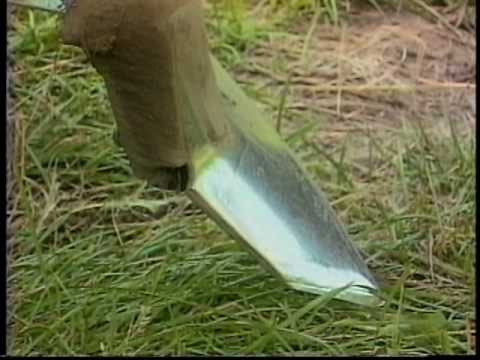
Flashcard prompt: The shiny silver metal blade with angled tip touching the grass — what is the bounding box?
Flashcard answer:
[188,58,378,304]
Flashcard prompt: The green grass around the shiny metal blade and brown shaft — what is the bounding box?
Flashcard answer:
[8,1,476,355]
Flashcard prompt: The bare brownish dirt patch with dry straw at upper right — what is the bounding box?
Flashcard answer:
[234,11,476,141]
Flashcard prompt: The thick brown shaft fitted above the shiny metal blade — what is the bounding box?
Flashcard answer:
[63,0,232,191]
